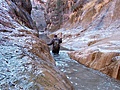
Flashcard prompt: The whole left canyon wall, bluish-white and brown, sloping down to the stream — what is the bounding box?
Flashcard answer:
[0,0,73,90]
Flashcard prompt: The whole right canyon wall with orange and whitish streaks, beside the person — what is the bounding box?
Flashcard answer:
[49,0,120,79]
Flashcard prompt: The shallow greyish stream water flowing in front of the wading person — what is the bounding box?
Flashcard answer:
[52,51,120,90]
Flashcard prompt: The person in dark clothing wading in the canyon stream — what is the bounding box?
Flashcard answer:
[47,35,62,54]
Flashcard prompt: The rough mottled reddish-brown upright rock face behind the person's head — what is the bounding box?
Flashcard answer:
[46,0,73,32]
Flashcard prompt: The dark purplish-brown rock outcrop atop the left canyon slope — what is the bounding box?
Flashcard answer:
[6,0,36,29]
